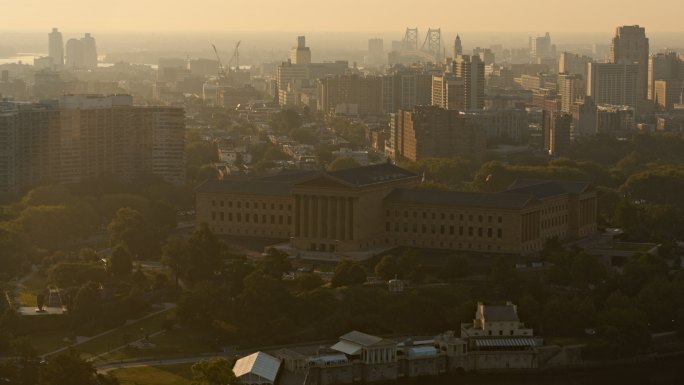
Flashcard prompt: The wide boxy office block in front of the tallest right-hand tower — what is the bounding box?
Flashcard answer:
[587,63,640,109]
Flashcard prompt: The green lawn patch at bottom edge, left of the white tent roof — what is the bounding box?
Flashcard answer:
[110,364,192,385]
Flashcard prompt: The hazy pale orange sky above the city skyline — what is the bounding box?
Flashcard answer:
[5,0,684,32]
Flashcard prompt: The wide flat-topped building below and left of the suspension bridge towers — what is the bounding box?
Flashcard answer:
[316,74,383,116]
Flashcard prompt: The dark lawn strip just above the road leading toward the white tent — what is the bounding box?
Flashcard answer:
[99,329,215,361]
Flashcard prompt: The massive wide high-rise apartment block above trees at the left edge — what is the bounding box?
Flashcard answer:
[0,95,185,192]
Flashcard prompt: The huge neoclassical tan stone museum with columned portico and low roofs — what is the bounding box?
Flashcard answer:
[196,165,597,254]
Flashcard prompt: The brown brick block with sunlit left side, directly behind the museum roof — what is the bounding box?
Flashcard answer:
[393,106,487,164]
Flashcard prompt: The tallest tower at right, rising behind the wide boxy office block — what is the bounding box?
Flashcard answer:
[612,25,649,103]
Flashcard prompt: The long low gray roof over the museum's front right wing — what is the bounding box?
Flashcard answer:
[385,189,536,209]
